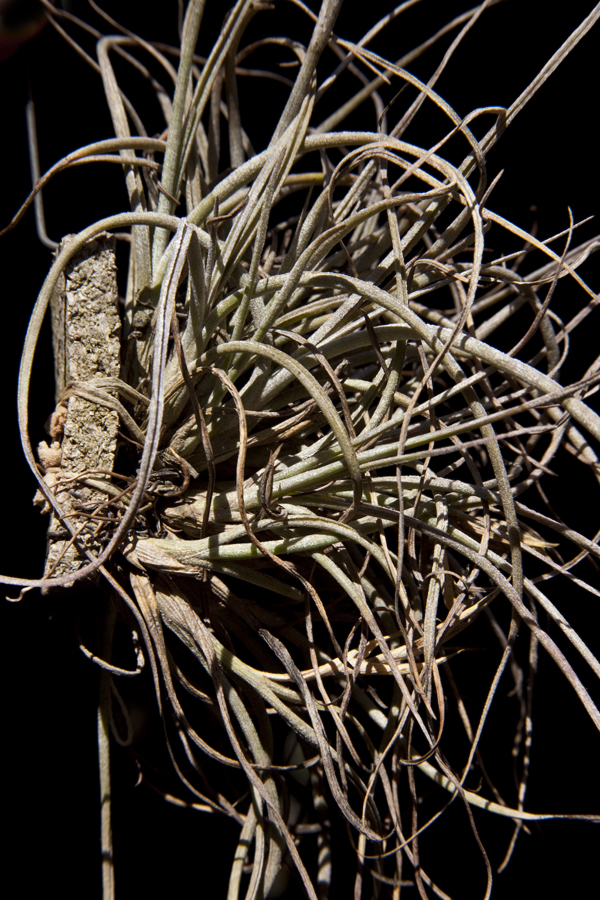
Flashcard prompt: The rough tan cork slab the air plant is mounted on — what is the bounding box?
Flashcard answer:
[39,234,121,577]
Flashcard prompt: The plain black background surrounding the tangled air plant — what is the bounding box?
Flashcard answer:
[0,0,600,898]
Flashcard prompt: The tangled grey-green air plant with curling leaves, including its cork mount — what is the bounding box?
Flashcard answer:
[2,0,600,900]
